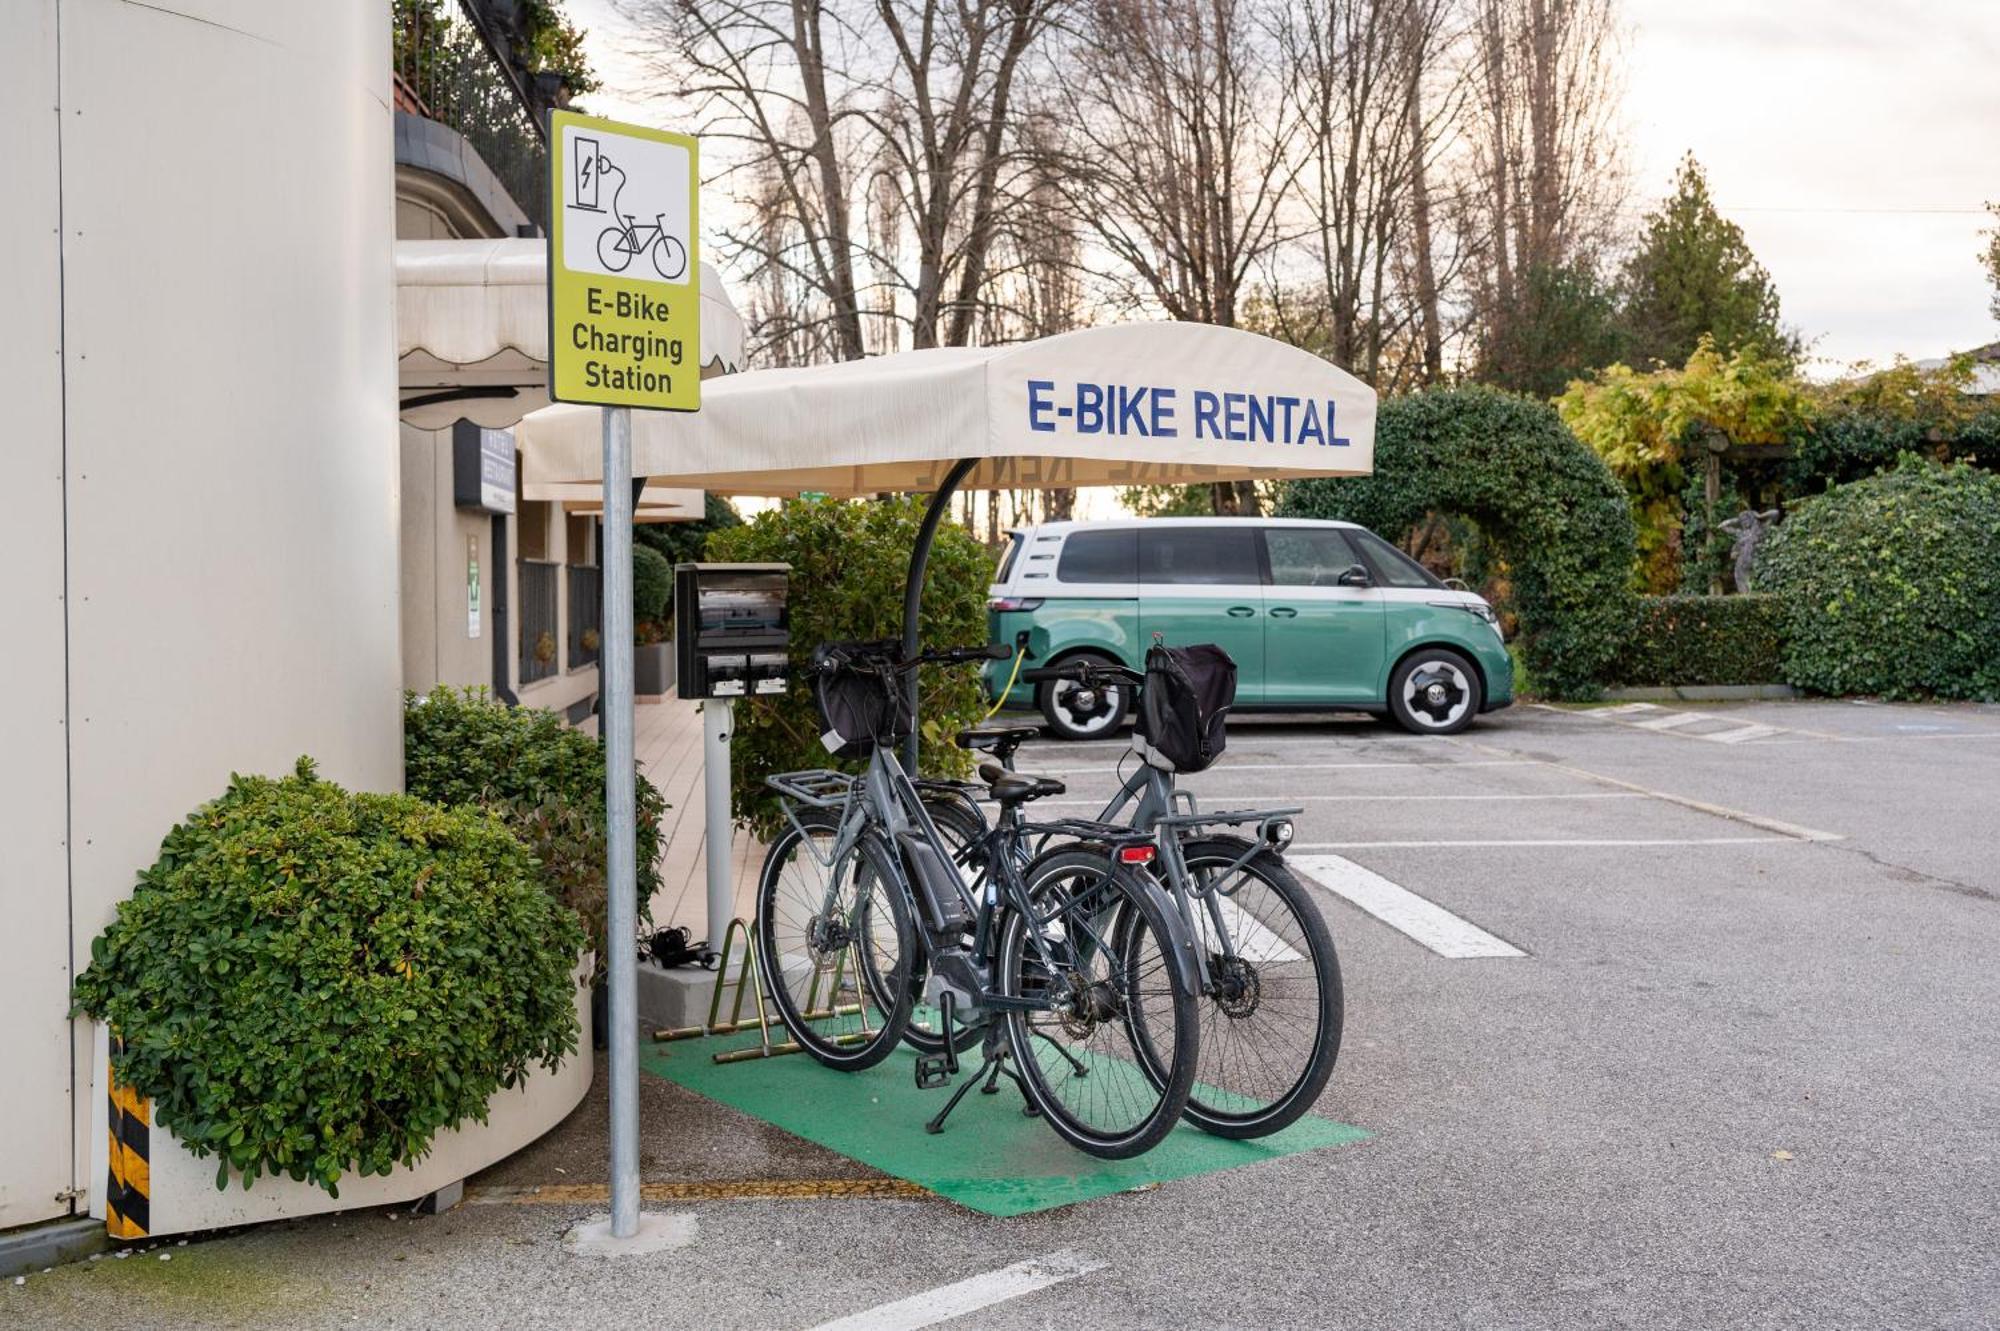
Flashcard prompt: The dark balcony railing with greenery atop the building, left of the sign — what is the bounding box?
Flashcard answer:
[390,0,548,222]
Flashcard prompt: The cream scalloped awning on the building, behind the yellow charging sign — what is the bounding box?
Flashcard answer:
[396,240,744,430]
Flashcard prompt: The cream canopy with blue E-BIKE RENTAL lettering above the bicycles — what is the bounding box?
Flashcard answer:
[518,324,1376,496]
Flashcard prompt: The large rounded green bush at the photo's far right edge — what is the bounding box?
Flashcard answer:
[1756,456,2000,699]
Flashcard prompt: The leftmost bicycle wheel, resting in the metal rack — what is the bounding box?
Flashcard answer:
[756,815,916,1071]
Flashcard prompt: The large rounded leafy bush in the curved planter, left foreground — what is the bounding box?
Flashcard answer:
[76,759,584,1195]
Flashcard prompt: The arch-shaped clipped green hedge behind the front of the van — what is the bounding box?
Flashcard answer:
[1278,388,1634,697]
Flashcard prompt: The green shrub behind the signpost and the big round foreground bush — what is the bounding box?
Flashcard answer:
[402,683,666,943]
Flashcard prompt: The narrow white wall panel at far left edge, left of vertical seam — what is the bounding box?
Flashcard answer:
[0,0,72,1229]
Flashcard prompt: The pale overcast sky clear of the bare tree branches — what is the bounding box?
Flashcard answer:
[566,0,2000,372]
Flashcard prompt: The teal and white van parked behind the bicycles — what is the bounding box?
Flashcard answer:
[986,518,1514,739]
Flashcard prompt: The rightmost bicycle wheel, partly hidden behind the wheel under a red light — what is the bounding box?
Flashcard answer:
[1138,837,1342,1139]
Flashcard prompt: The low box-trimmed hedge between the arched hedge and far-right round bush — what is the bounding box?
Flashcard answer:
[1610,594,1784,687]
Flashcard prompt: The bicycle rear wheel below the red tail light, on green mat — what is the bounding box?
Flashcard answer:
[1000,849,1198,1159]
